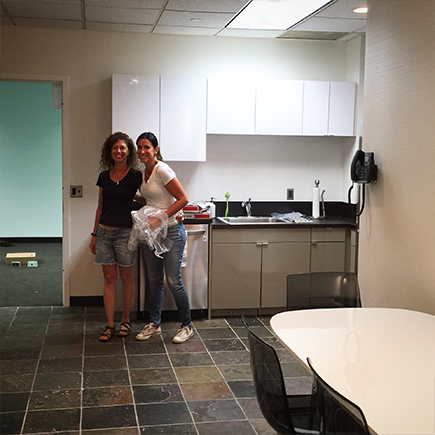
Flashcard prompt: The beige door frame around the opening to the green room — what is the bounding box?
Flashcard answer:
[0,73,71,307]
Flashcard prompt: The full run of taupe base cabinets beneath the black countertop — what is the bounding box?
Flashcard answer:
[210,228,351,310]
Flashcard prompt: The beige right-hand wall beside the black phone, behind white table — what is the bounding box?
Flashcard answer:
[359,0,435,314]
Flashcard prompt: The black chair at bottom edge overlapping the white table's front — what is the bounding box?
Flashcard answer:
[307,358,370,434]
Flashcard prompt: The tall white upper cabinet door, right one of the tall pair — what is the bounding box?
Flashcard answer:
[160,77,207,162]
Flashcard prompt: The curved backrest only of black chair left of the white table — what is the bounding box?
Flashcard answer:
[242,317,296,434]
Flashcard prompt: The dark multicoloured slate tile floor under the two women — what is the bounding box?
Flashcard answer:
[0,307,312,435]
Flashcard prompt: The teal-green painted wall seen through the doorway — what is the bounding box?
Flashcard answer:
[0,81,62,237]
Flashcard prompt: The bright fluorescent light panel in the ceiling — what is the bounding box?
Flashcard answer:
[227,0,330,30]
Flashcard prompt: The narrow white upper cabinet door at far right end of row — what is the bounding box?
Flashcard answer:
[328,82,356,136]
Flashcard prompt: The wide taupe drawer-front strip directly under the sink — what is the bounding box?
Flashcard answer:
[213,228,310,243]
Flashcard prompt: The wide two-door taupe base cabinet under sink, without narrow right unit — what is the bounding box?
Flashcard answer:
[210,229,310,309]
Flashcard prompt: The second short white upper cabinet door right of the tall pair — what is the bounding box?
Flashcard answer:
[255,80,304,136]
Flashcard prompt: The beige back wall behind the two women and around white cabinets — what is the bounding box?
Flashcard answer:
[0,26,361,303]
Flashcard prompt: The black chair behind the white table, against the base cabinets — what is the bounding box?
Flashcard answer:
[287,272,361,310]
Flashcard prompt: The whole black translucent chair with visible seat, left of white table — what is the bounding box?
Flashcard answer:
[242,317,319,434]
